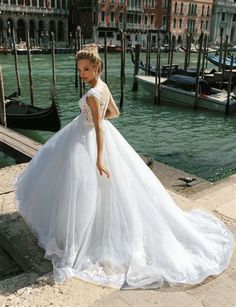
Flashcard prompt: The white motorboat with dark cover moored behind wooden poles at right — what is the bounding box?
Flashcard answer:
[136,74,236,113]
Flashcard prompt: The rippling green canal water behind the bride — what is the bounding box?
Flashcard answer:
[0,52,236,181]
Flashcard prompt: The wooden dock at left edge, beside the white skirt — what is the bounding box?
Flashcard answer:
[0,125,42,162]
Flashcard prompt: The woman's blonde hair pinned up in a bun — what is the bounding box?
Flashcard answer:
[76,44,103,74]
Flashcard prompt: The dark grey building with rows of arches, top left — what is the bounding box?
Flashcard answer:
[0,0,68,48]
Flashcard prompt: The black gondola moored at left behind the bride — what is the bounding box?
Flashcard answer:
[5,85,61,132]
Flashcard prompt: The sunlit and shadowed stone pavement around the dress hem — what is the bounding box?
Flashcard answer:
[0,162,236,307]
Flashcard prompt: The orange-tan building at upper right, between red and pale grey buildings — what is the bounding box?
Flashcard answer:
[167,0,214,44]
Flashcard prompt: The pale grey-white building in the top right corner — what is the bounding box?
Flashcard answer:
[211,0,236,44]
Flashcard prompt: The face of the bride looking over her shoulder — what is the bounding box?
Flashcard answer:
[77,60,98,85]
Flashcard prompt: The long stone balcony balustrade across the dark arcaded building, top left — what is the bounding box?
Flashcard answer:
[0,4,69,16]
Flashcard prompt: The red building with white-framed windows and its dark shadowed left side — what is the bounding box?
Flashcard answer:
[69,0,161,46]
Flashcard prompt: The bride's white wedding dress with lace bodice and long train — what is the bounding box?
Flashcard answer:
[15,80,234,288]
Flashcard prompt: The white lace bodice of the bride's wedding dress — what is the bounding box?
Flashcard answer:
[79,79,111,126]
